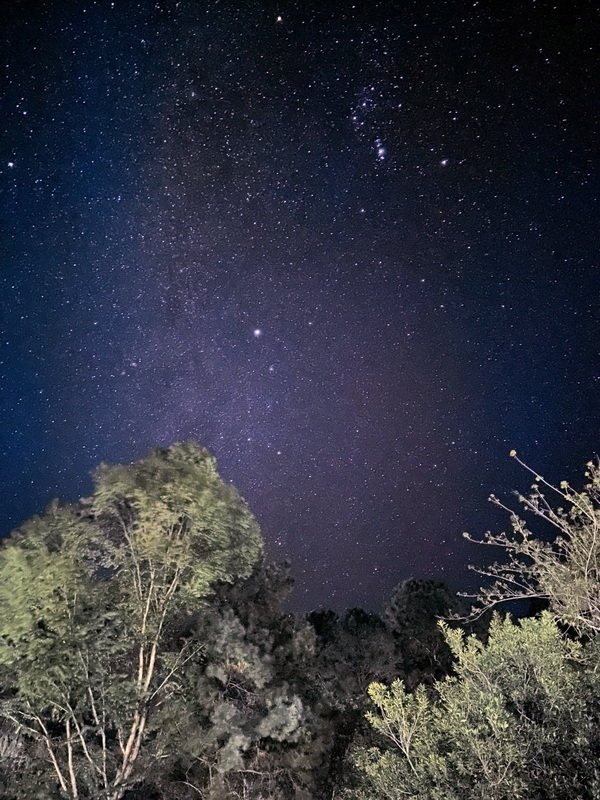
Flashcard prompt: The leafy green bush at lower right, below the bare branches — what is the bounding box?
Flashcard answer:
[353,612,600,800]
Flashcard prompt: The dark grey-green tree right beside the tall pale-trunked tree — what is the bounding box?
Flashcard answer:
[135,562,327,800]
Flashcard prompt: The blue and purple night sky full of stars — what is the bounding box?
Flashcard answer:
[0,0,600,610]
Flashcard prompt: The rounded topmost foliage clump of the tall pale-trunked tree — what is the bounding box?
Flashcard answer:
[92,442,262,603]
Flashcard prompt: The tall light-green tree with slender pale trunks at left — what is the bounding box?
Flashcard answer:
[0,443,262,800]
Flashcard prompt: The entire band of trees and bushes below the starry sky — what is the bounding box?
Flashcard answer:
[0,442,600,800]
